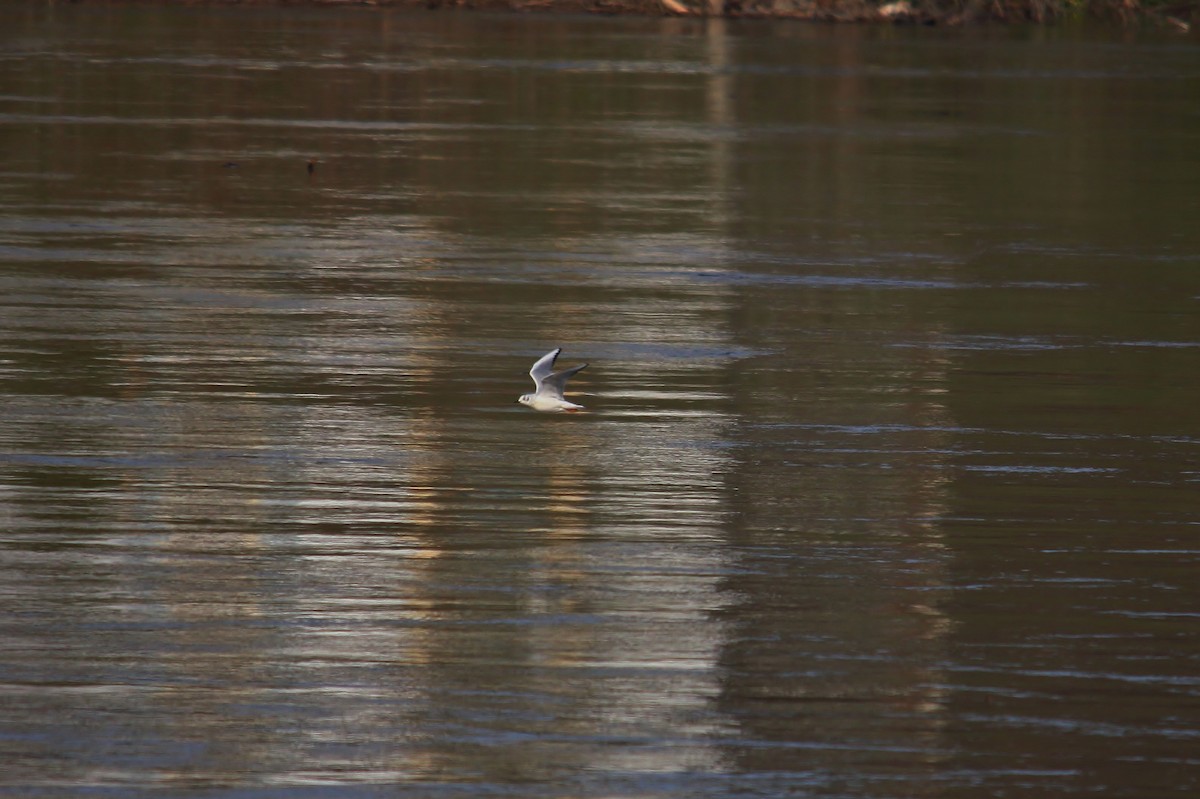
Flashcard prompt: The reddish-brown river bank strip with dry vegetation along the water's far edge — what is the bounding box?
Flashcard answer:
[76,0,1200,27]
